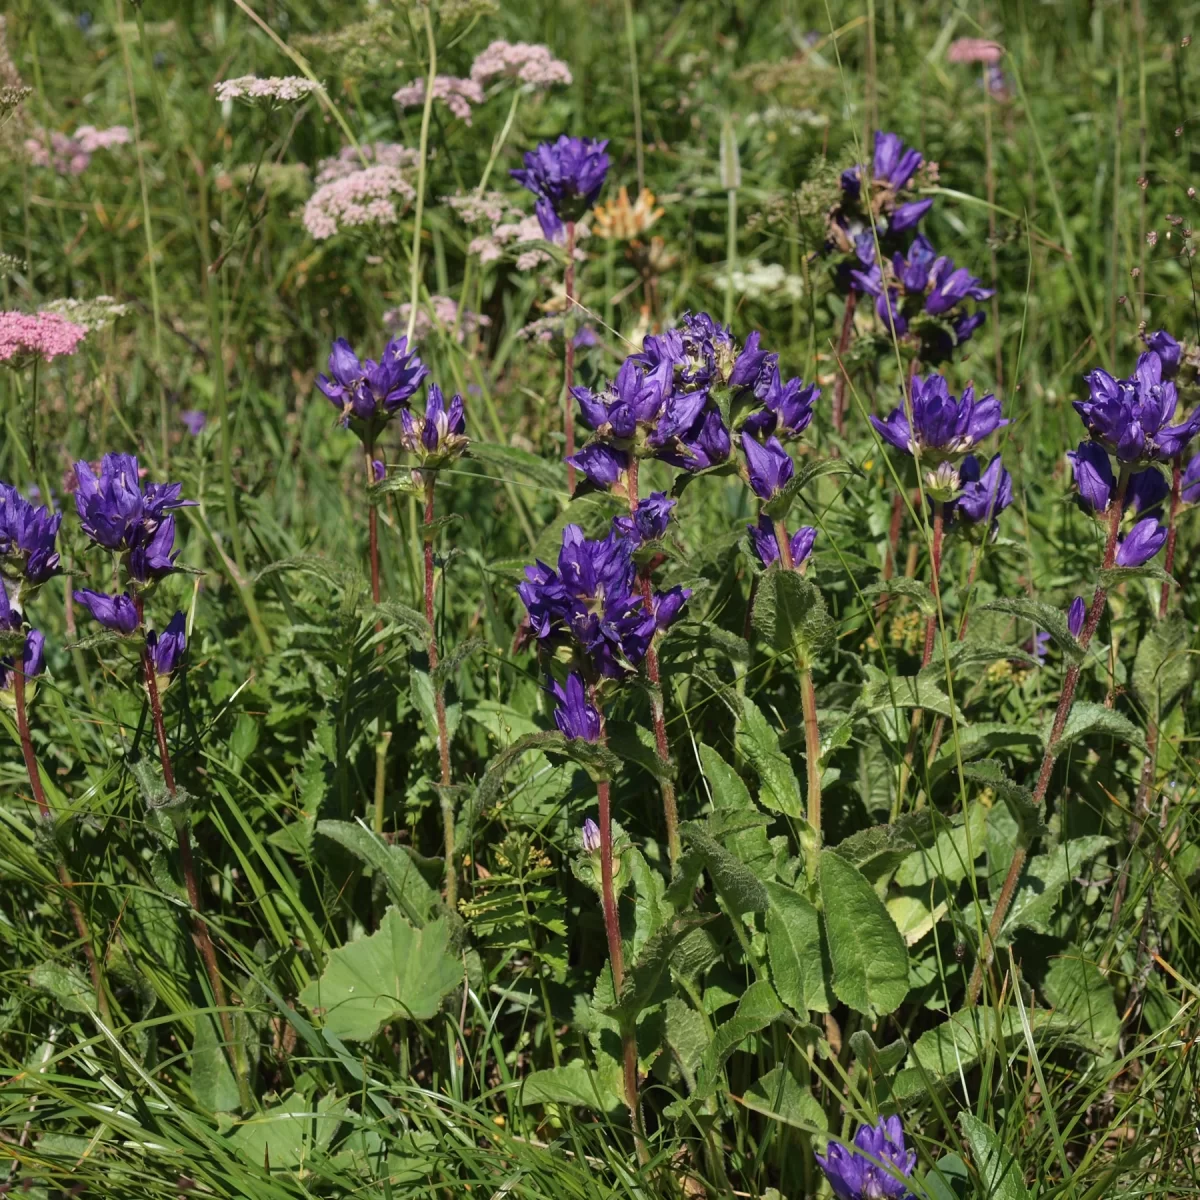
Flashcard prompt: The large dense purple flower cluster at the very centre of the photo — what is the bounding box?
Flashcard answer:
[517,524,691,679]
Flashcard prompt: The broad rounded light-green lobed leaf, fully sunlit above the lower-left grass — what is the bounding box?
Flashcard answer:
[300,908,463,1042]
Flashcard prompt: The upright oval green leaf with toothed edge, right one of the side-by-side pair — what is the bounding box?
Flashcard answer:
[821,850,908,1018]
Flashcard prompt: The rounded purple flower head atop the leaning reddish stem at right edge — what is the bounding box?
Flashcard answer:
[1074,350,1200,463]
